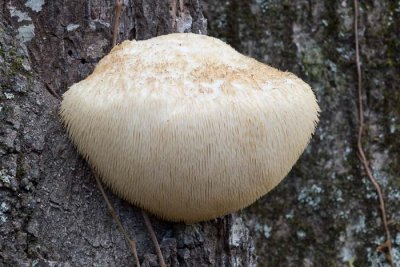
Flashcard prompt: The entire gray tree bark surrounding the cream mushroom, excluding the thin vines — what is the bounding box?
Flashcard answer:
[0,0,400,266]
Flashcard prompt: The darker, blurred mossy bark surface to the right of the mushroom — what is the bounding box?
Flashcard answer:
[205,0,400,266]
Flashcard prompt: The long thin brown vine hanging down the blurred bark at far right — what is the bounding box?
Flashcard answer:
[354,0,395,267]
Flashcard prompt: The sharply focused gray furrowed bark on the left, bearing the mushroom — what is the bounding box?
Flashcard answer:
[0,0,255,266]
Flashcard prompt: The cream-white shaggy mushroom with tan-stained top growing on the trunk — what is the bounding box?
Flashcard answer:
[61,33,319,223]
